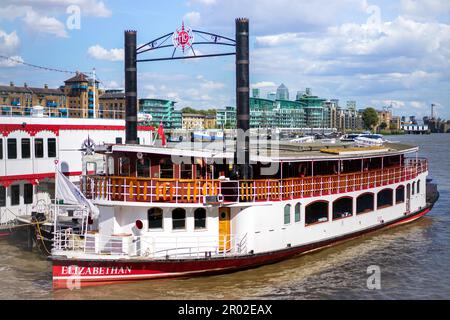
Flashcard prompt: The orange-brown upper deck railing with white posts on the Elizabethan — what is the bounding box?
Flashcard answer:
[82,159,428,204]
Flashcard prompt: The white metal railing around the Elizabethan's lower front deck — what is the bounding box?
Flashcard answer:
[53,229,247,259]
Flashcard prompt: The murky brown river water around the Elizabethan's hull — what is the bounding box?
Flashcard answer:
[0,134,450,300]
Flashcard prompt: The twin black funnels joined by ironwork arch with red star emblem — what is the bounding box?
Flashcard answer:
[124,18,252,179]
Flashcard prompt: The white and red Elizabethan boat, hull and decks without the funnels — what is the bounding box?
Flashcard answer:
[52,135,435,287]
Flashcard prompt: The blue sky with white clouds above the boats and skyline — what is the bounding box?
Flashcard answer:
[0,0,450,119]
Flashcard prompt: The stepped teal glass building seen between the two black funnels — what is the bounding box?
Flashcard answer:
[139,99,183,129]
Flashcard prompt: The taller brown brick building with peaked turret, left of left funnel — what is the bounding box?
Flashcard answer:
[64,72,99,118]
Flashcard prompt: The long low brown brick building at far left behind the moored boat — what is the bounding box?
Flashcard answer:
[0,82,67,117]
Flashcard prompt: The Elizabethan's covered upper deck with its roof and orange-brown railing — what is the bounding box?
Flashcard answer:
[82,144,428,204]
